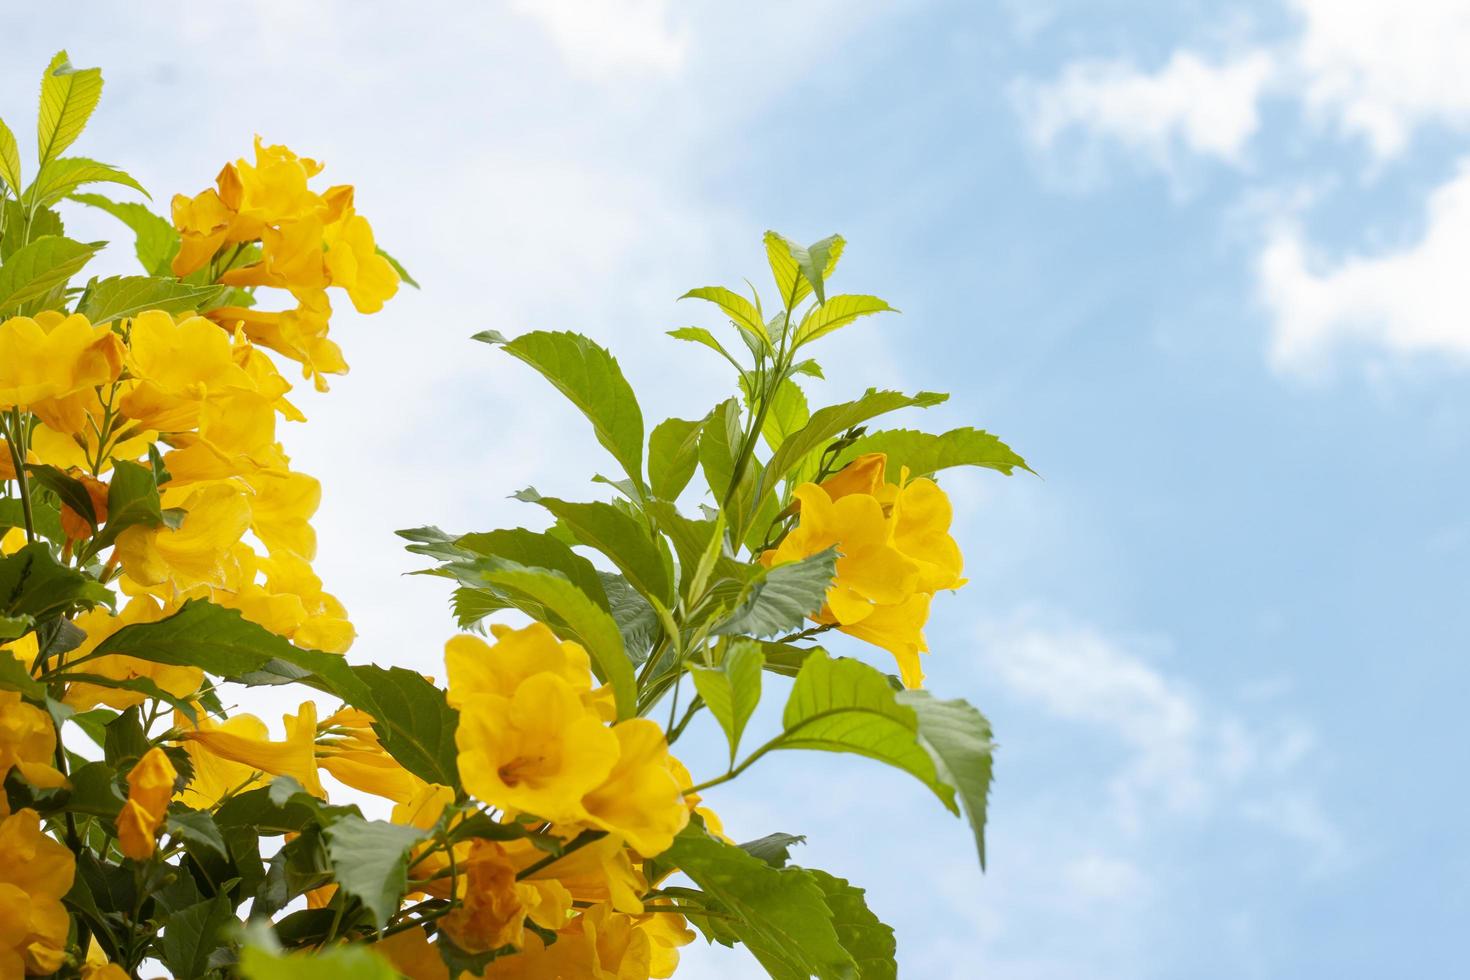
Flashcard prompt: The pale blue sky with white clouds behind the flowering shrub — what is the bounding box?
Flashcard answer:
[0,0,1470,980]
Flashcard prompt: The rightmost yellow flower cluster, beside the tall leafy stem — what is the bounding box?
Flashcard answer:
[760,453,964,688]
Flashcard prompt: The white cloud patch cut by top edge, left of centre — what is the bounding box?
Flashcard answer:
[513,0,688,78]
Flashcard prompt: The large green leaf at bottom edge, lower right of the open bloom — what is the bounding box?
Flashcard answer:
[660,823,857,980]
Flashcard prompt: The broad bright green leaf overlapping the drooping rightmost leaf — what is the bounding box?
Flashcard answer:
[776,652,960,814]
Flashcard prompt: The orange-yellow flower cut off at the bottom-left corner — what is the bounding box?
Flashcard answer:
[0,810,76,977]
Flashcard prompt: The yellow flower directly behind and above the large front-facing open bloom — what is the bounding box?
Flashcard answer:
[444,623,592,708]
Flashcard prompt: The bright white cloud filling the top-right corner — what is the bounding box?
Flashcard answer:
[1292,0,1470,157]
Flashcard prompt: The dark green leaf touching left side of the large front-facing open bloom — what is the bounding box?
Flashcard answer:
[353,664,460,790]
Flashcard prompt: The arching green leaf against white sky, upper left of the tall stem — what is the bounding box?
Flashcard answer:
[488,331,644,485]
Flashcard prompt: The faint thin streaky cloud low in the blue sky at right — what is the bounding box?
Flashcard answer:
[982,608,1344,863]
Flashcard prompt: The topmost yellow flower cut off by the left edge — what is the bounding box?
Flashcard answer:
[0,313,122,432]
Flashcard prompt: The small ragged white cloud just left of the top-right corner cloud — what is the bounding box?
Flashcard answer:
[1013,51,1273,167]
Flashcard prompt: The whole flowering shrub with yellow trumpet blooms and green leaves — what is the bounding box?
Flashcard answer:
[0,53,1025,980]
